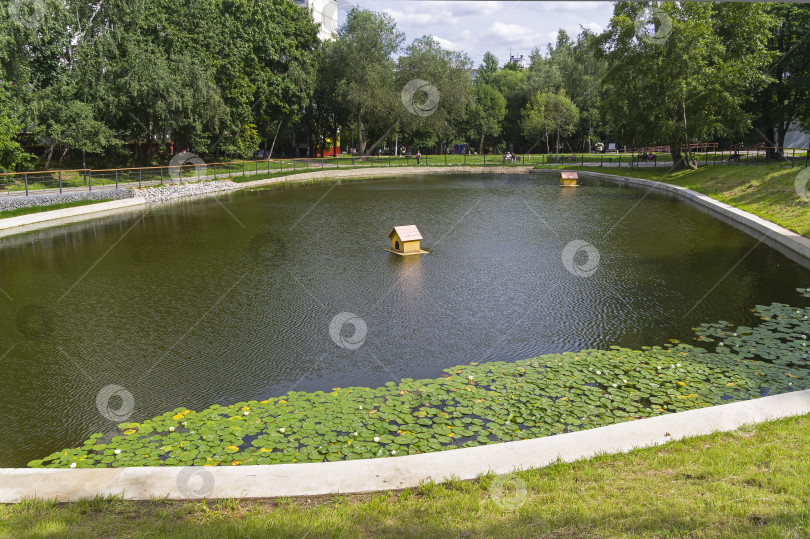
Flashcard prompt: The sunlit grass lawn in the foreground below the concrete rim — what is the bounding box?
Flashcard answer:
[0,416,810,539]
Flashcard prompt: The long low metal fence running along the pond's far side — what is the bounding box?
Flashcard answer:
[0,148,810,196]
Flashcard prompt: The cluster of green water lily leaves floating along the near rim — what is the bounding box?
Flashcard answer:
[29,291,810,468]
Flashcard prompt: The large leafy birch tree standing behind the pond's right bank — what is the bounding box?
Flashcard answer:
[596,2,772,168]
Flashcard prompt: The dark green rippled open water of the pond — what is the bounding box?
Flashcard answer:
[0,176,810,466]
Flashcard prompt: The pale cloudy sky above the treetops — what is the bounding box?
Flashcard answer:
[338,0,613,66]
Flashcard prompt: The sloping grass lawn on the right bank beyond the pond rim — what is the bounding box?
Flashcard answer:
[541,165,810,238]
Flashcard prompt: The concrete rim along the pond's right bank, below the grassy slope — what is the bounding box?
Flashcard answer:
[531,169,810,264]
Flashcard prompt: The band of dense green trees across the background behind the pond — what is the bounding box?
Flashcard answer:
[0,0,810,170]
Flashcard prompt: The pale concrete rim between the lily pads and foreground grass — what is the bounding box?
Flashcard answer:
[0,390,810,503]
